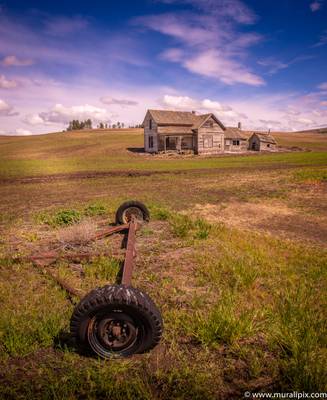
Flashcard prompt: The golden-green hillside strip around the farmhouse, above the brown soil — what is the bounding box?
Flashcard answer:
[0,129,327,178]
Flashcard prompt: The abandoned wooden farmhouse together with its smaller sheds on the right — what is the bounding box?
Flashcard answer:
[143,110,276,154]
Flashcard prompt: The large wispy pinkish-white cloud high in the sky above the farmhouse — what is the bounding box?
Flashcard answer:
[134,0,264,86]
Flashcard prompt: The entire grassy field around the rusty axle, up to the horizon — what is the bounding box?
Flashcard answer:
[0,130,327,400]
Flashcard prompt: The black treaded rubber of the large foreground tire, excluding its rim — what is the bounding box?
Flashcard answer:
[70,285,163,358]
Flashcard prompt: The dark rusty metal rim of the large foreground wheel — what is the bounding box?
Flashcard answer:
[87,312,140,358]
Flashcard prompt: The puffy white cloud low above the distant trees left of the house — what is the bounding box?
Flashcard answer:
[39,104,109,124]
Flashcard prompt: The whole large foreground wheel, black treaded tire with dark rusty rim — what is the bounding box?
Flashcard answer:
[70,285,163,358]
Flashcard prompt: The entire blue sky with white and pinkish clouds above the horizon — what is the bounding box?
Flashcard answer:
[0,0,327,135]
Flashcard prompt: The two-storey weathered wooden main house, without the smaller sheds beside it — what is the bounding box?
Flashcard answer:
[143,110,226,154]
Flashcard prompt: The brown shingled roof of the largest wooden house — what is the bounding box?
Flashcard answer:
[148,110,225,130]
